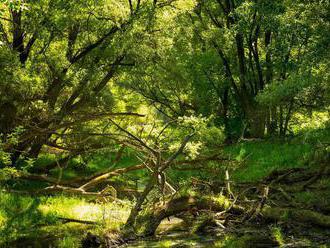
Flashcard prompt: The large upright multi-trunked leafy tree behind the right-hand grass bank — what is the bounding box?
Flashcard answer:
[124,0,329,139]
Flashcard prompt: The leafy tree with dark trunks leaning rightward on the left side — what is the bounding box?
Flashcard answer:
[0,0,196,164]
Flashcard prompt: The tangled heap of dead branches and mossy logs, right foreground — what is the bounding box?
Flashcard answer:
[104,149,330,246]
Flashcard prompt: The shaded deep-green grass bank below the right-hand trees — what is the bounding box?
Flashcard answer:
[168,127,330,182]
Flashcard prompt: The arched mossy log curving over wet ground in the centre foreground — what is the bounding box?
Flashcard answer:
[136,196,244,237]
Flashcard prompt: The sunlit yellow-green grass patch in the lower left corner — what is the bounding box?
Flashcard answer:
[0,193,130,247]
